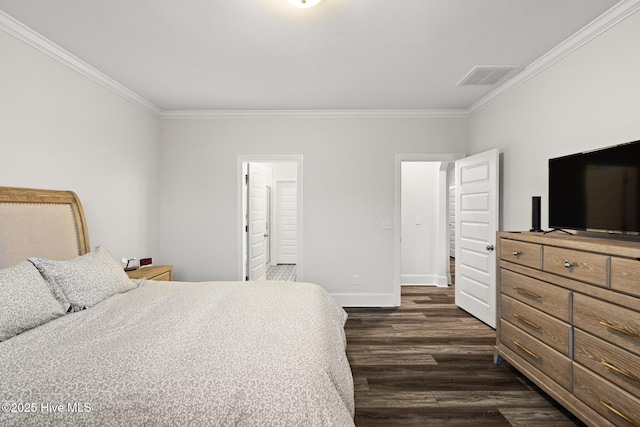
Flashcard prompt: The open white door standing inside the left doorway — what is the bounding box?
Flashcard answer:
[247,163,267,280]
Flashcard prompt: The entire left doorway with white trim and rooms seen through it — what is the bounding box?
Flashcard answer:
[237,155,303,281]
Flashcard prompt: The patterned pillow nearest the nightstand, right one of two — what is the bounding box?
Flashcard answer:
[29,246,136,311]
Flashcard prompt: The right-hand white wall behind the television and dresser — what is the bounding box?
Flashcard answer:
[469,13,640,230]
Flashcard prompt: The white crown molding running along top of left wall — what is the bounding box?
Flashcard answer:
[0,10,162,117]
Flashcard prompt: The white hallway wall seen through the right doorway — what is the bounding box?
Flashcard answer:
[400,162,447,285]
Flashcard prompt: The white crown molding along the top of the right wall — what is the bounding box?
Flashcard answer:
[468,0,640,116]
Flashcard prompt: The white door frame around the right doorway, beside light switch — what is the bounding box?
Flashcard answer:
[393,153,466,307]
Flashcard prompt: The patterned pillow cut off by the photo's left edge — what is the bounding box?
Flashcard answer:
[0,260,68,341]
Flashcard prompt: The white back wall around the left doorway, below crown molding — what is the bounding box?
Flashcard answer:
[161,118,467,305]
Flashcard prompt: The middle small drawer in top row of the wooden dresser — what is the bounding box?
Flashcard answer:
[543,246,609,287]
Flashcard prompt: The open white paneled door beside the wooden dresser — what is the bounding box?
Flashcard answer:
[455,149,499,328]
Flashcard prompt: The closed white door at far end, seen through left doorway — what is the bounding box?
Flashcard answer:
[278,181,298,264]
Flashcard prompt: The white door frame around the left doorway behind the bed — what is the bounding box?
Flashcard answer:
[236,154,304,282]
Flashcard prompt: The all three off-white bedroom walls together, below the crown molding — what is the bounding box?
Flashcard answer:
[0,4,640,305]
